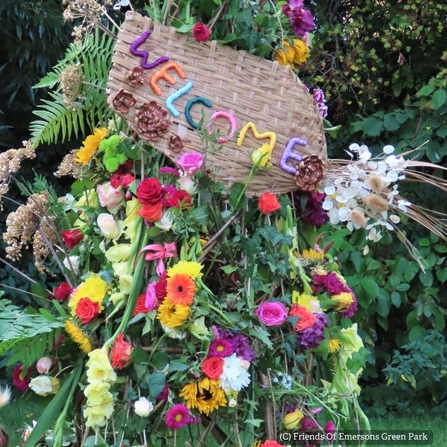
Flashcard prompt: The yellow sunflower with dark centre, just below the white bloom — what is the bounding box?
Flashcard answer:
[179,377,227,416]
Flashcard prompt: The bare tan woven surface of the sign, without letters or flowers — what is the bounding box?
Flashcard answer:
[108,12,327,195]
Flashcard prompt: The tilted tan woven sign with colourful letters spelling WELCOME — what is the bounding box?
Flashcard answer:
[108,12,327,195]
